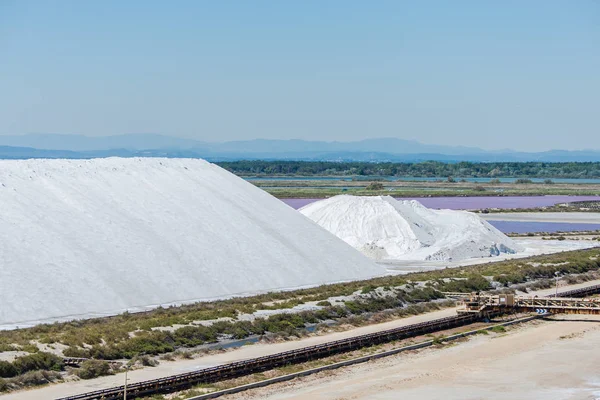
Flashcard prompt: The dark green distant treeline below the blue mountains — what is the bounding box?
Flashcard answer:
[217,161,600,178]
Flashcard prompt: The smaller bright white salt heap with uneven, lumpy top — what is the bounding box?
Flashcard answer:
[300,195,522,261]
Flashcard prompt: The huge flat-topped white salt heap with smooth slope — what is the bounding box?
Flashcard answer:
[0,158,384,328]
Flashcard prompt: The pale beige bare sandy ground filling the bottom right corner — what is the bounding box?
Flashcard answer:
[232,315,600,400]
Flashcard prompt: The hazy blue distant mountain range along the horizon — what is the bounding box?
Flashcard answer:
[0,134,600,162]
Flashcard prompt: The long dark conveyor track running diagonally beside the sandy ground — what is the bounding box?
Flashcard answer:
[57,285,600,400]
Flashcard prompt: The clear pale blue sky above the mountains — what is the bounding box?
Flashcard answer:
[0,0,600,150]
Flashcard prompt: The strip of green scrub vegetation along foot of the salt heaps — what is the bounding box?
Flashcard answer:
[0,249,600,390]
